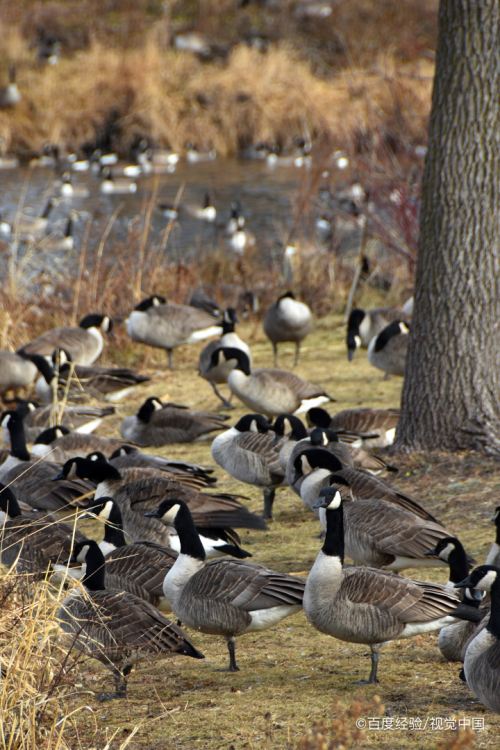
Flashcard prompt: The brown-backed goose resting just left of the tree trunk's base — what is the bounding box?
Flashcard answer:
[307,408,400,448]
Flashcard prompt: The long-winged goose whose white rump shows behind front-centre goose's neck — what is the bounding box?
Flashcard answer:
[57,454,266,557]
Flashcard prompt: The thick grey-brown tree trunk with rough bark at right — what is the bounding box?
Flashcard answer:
[395,0,500,455]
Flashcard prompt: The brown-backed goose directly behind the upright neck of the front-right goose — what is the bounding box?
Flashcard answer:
[318,484,458,572]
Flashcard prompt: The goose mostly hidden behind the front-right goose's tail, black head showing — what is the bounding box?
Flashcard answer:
[426,536,484,661]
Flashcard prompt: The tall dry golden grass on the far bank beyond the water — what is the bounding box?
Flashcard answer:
[0,0,435,157]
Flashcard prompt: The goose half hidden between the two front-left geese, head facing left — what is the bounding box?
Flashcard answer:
[80,497,177,611]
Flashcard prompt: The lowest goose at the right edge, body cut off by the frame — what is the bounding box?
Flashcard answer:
[455,565,500,713]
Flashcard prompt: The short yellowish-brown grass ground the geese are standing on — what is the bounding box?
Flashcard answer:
[0,308,500,750]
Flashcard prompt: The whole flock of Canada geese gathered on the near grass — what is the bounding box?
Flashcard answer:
[0,292,500,712]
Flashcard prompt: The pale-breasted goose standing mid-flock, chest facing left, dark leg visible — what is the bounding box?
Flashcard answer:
[211,414,286,518]
